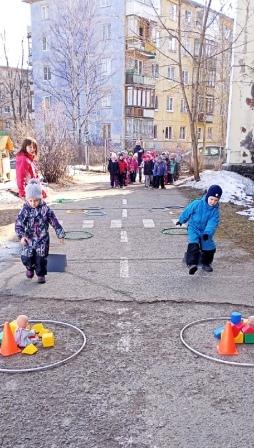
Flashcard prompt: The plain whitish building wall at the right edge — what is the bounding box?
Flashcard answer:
[227,0,254,164]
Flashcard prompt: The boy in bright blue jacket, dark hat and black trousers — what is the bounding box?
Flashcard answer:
[176,185,222,275]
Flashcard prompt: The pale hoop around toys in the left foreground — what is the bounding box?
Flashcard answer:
[0,319,86,373]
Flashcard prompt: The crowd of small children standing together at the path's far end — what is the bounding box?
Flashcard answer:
[108,150,180,189]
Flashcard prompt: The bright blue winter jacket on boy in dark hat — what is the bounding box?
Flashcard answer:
[178,196,220,250]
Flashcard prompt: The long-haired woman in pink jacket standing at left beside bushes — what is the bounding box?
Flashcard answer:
[16,138,38,198]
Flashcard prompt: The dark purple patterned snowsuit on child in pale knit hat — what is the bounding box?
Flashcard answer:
[15,201,65,277]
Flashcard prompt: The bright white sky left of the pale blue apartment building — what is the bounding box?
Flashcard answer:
[0,0,30,66]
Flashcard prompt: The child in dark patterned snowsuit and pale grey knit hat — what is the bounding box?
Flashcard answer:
[15,179,65,283]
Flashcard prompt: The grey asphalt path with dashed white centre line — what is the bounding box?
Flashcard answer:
[0,179,254,448]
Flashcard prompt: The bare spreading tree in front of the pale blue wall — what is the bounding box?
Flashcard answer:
[39,0,107,149]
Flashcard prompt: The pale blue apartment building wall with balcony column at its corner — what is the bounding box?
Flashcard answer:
[23,0,158,148]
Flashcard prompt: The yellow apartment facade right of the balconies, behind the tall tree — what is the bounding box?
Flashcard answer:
[154,0,233,151]
